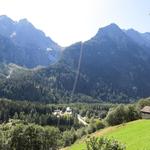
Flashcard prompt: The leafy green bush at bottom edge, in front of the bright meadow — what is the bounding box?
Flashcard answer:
[86,137,126,150]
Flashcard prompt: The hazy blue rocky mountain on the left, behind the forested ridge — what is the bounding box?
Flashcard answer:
[0,16,61,67]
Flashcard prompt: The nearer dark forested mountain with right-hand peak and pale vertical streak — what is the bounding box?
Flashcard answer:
[0,24,150,102]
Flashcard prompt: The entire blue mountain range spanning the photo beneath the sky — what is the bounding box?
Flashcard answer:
[0,17,150,102]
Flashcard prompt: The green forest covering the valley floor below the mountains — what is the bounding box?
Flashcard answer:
[0,99,150,150]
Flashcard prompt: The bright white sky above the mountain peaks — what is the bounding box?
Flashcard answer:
[0,0,150,46]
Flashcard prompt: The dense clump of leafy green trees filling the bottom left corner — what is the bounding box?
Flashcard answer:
[0,121,61,150]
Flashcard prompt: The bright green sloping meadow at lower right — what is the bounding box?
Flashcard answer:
[66,120,150,150]
